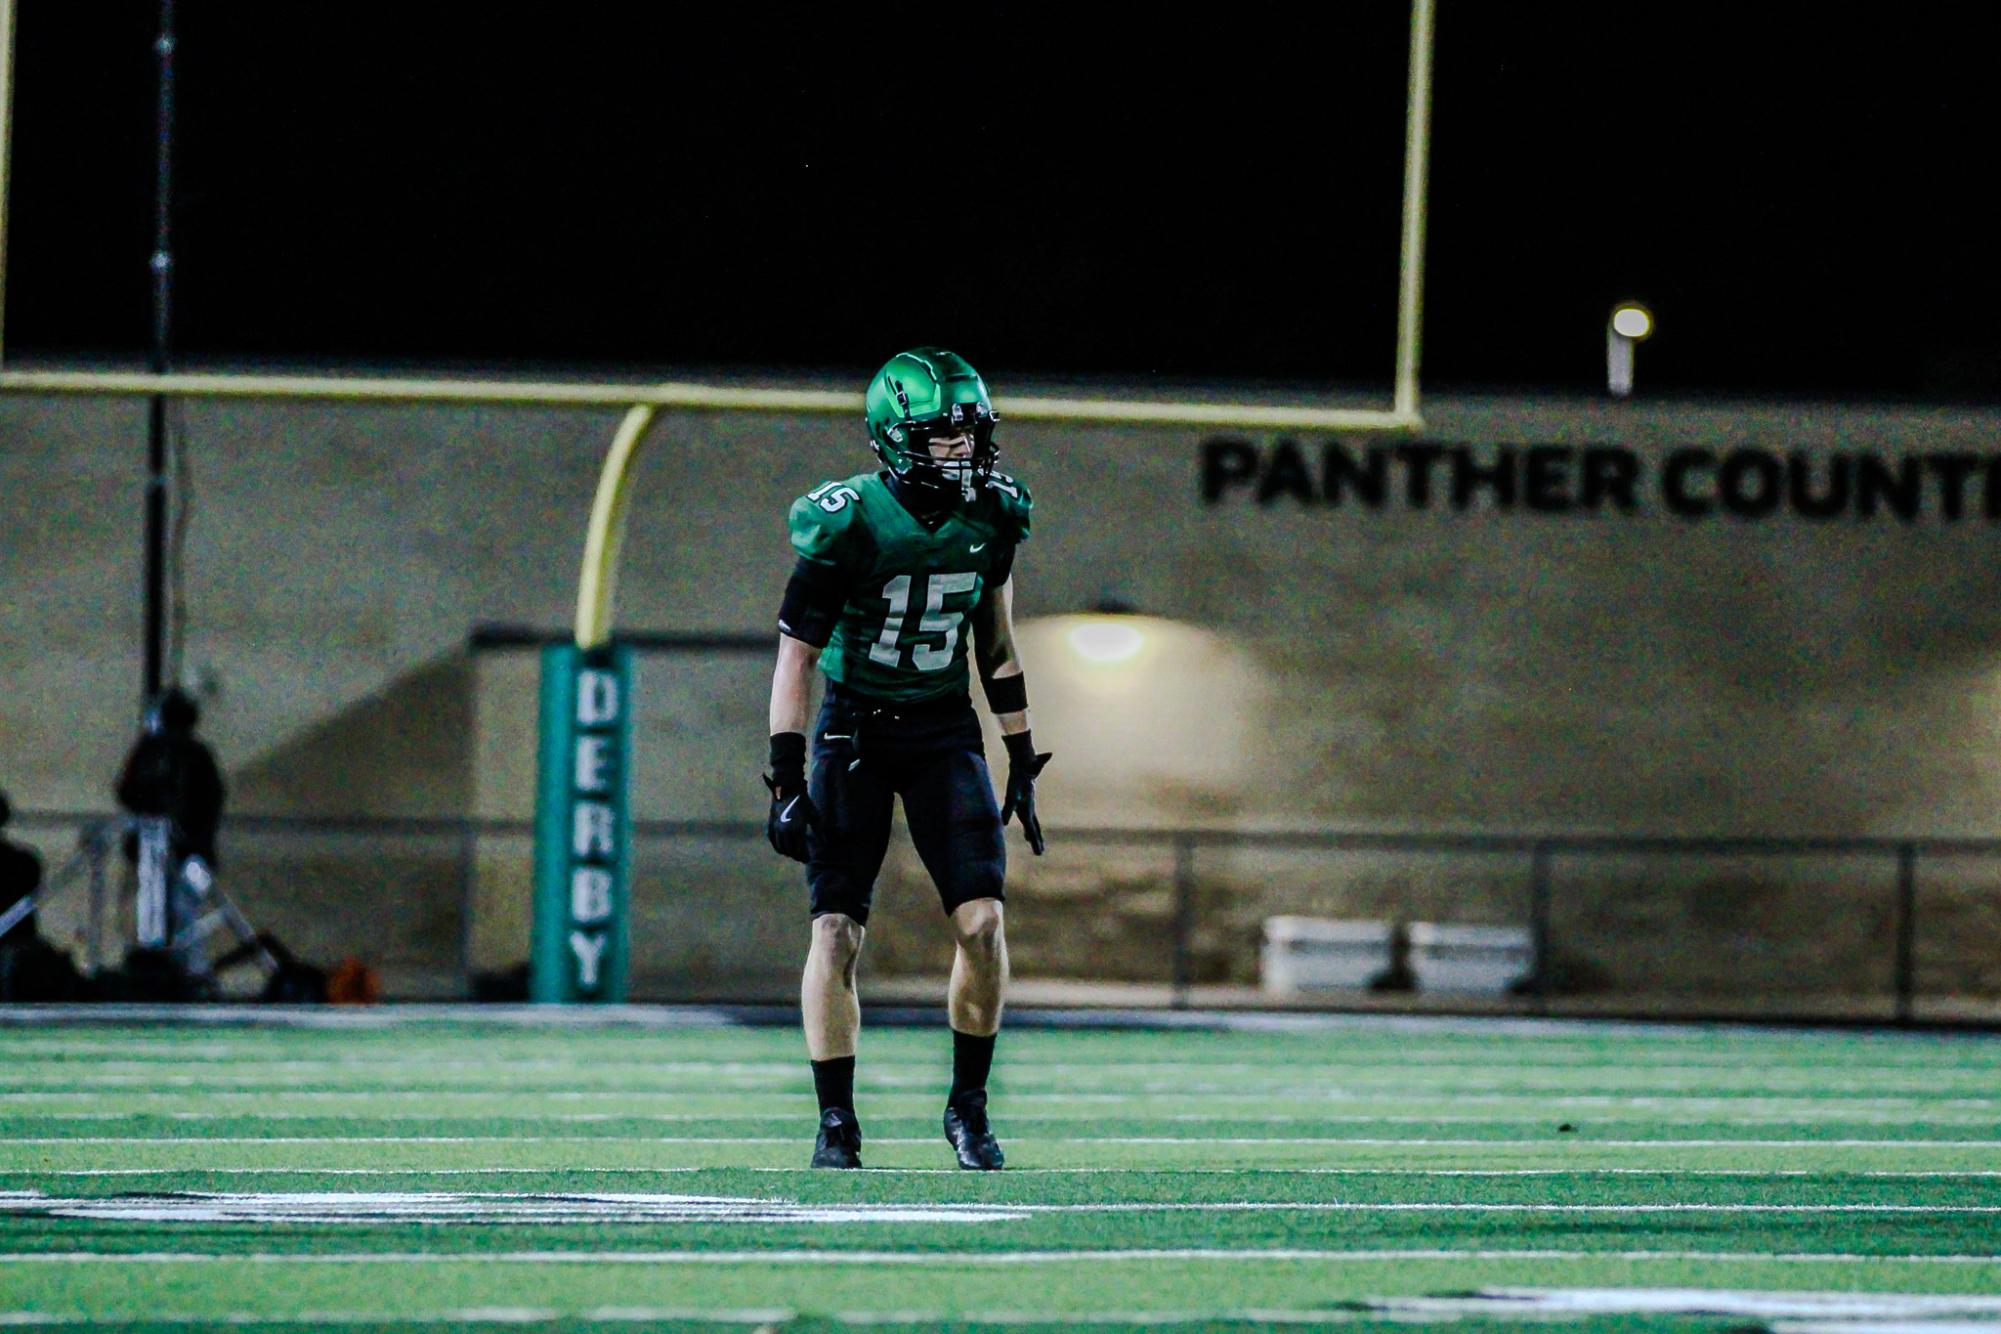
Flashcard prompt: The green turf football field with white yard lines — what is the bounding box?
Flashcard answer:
[0,1010,2001,1334]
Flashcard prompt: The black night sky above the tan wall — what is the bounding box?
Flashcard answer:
[6,0,2001,400]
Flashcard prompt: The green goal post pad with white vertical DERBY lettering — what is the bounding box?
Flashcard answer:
[528,644,632,1002]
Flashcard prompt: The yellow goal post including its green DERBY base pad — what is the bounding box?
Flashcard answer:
[0,0,1435,1002]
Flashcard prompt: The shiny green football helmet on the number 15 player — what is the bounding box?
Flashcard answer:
[866,348,1001,502]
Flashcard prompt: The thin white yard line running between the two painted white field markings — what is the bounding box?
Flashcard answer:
[0,1248,2001,1268]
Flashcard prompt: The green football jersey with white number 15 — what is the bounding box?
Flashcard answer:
[790,472,1035,702]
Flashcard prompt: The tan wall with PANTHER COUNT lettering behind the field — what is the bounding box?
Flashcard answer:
[0,382,2001,1008]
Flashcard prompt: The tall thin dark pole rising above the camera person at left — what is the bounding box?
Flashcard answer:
[140,0,174,708]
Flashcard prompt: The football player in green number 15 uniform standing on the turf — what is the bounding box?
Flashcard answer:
[764,348,1049,1170]
